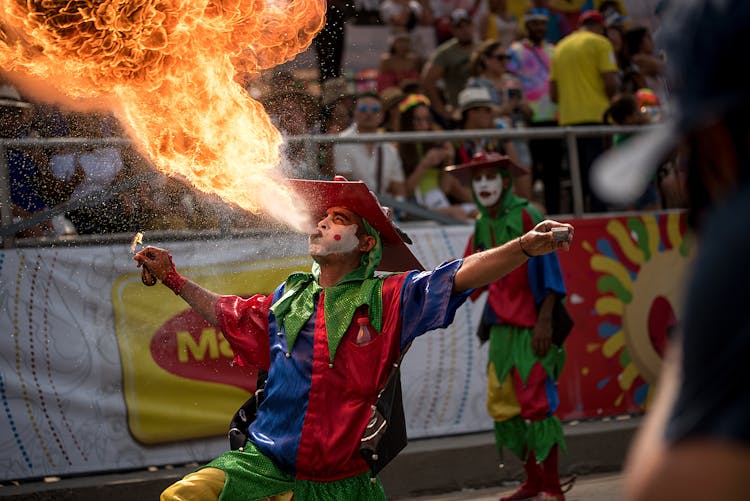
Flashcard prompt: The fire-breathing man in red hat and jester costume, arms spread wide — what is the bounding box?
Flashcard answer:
[135,179,572,501]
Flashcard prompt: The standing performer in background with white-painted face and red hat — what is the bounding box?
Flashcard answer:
[446,153,565,501]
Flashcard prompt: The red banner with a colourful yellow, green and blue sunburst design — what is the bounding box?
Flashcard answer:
[558,213,691,420]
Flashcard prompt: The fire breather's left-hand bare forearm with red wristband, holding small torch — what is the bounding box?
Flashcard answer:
[133,247,219,325]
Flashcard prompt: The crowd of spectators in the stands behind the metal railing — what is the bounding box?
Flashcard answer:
[0,0,684,237]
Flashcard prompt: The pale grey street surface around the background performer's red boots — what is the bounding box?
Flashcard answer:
[400,473,624,501]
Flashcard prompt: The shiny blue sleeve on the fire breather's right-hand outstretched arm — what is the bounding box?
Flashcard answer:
[401,259,472,349]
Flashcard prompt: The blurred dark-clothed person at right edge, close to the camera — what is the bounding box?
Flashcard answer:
[592,0,750,501]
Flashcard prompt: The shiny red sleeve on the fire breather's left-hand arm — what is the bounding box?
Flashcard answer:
[216,294,273,370]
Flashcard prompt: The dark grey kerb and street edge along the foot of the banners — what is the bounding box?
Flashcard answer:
[0,417,640,501]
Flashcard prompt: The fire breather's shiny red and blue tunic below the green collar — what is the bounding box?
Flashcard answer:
[216,260,467,481]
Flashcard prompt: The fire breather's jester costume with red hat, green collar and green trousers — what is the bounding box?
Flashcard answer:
[167,183,468,501]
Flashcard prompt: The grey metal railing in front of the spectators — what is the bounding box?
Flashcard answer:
[0,125,658,248]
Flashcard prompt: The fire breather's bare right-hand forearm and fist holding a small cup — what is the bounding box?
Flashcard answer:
[453,220,573,292]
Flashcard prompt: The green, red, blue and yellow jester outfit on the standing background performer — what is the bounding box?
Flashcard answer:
[465,190,565,461]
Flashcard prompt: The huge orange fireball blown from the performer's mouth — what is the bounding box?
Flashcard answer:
[0,0,326,230]
